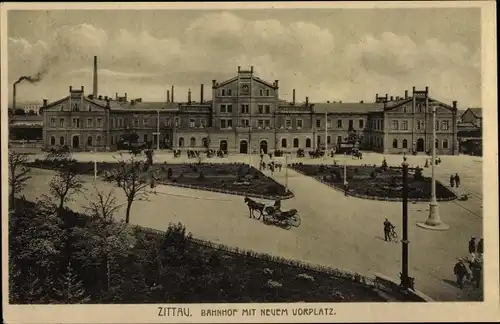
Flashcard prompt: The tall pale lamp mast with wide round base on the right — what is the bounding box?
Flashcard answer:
[417,106,450,231]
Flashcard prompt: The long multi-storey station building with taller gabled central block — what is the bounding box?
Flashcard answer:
[42,67,458,154]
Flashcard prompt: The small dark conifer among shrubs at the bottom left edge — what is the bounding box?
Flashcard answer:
[54,262,89,304]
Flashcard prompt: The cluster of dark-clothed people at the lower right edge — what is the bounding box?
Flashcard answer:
[453,237,483,289]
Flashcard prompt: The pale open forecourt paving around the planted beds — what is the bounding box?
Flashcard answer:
[21,154,482,301]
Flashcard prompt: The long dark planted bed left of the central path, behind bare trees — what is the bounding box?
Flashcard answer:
[28,160,293,199]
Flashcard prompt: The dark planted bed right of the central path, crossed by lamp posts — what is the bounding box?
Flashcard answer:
[291,163,457,201]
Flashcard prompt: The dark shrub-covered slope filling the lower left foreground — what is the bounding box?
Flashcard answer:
[9,200,385,304]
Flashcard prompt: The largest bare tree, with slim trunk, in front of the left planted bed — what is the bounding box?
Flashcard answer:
[108,156,149,224]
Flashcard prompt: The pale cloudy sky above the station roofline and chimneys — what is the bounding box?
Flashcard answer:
[7,8,481,109]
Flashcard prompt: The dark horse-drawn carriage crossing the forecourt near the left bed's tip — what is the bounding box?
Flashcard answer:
[245,197,301,229]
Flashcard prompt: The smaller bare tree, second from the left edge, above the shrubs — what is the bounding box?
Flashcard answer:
[49,162,84,210]
